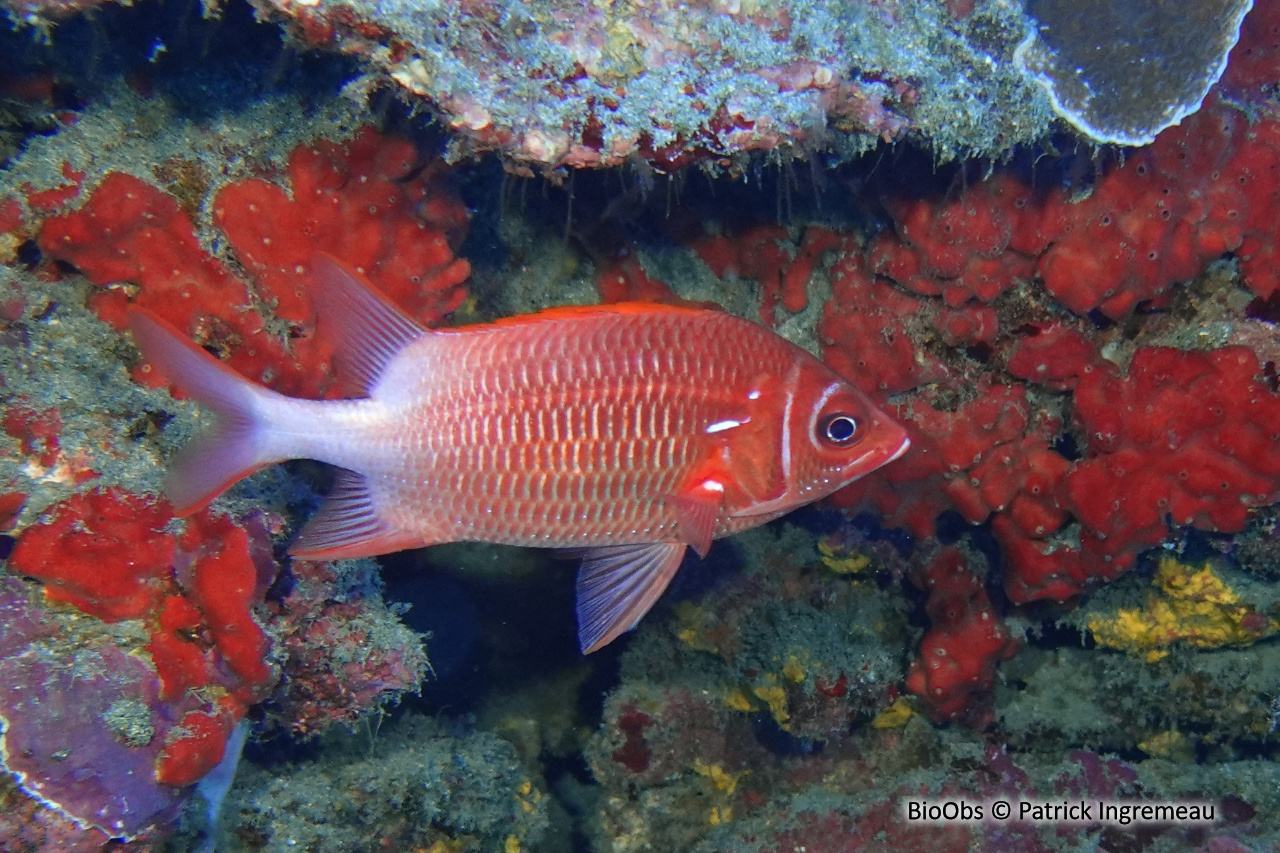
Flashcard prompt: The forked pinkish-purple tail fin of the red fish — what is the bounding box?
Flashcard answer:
[129,307,287,515]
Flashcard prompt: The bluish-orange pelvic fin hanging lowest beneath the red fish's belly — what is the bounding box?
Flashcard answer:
[576,542,685,654]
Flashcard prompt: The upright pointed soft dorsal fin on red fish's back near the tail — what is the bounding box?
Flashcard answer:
[311,254,430,393]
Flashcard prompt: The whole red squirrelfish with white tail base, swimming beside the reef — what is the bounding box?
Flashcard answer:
[132,256,908,652]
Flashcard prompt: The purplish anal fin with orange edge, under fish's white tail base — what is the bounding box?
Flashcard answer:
[289,469,419,560]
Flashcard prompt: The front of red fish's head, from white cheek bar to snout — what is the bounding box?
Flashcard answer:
[785,359,911,506]
